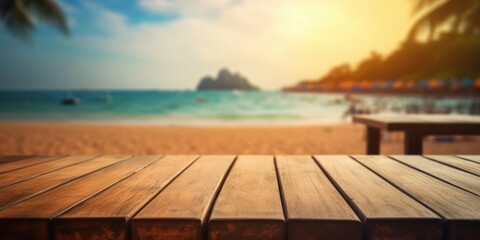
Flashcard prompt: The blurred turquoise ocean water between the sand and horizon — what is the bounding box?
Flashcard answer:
[0,91,473,125]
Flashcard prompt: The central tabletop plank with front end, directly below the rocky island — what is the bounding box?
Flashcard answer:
[208,156,285,240]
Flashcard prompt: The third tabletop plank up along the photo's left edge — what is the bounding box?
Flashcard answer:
[0,156,94,187]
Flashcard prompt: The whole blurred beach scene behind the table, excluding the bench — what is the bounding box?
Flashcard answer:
[0,0,480,155]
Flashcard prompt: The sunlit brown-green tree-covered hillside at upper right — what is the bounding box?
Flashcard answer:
[320,0,480,82]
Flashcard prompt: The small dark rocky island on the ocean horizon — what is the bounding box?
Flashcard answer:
[197,68,259,91]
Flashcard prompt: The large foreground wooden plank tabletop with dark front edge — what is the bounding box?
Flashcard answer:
[0,155,480,240]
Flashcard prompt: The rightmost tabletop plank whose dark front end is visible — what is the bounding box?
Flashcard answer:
[355,156,480,239]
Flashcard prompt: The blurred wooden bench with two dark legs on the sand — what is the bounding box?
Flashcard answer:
[353,115,480,155]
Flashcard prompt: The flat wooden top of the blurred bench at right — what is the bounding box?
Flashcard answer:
[353,114,480,131]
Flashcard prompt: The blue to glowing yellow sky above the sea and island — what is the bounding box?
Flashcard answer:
[0,0,412,89]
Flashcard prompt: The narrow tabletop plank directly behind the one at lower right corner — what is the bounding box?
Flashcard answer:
[391,155,480,196]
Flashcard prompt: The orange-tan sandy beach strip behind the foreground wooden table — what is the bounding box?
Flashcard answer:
[0,123,480,155]
